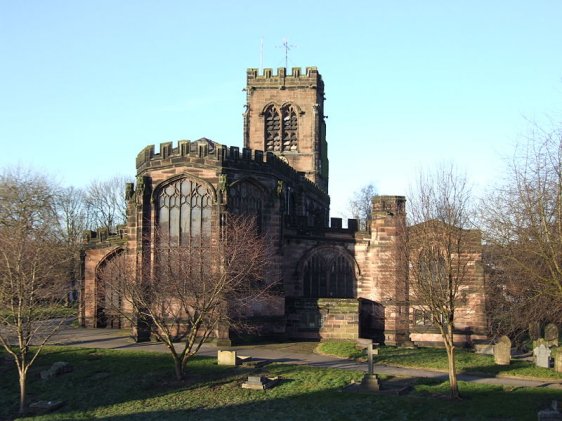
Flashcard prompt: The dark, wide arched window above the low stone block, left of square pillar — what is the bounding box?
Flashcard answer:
[303,250,355,298]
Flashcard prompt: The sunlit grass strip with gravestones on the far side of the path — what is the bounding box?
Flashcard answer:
[317,341,562,380]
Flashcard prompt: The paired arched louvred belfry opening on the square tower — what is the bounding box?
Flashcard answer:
[264,104,298,152]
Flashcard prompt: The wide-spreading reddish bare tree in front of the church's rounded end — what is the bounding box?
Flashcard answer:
[101,215,273,380]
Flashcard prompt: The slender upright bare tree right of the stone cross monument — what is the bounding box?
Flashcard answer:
[404,167,471,398]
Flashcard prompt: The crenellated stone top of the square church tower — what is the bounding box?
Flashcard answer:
[246,67,324,89]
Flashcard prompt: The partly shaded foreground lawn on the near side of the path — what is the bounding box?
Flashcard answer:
[0,347,560,420]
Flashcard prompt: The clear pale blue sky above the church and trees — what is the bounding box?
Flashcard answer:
[0,0,562,215]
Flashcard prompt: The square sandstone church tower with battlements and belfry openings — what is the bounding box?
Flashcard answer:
[244,67,328,193]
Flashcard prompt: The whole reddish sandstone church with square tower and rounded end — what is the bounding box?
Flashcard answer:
[82,67,486,345]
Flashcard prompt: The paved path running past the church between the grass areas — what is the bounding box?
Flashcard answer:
[51,328,562,391]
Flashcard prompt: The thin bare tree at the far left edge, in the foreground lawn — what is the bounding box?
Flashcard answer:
[0,170,66,413]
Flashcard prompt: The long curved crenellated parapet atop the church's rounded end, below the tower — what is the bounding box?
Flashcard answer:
[136,138,326,195]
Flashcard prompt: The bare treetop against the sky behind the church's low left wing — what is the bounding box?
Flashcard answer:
[85,176,130,232]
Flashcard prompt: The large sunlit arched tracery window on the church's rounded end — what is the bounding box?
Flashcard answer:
[157,178,212,245]
